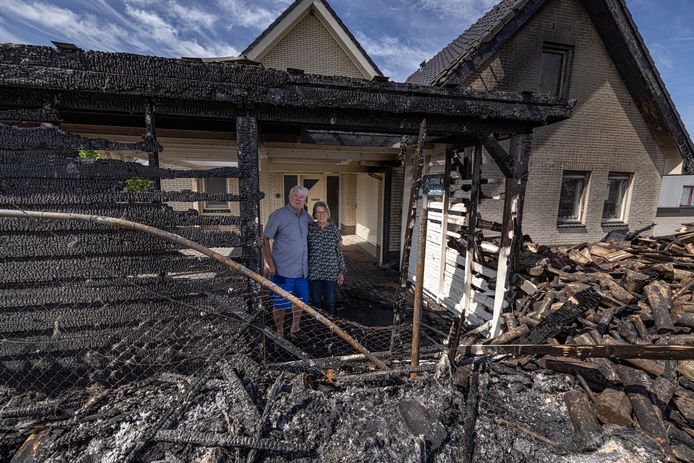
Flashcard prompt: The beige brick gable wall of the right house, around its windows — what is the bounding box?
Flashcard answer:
[467,0,677,244]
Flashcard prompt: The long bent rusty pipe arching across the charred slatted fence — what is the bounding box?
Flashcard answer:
[0,209,388,370]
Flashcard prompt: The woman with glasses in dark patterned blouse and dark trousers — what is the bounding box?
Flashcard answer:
[308,201,346,314]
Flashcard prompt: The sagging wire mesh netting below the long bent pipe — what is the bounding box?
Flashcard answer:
[0,232,444,397]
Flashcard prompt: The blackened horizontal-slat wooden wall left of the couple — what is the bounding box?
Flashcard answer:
[0,115,261,390]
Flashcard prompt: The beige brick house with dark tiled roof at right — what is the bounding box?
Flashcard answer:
[407,0,694,244]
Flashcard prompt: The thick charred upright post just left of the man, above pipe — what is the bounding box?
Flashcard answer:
[236,113,261,272]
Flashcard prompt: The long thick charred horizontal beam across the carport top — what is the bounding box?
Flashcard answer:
[0,44,573,127]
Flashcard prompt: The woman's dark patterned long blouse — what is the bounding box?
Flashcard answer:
[308,222,346,281]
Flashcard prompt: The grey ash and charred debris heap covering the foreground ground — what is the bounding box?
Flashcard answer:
[2,356,665,463]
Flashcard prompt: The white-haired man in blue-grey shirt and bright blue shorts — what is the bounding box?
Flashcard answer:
[263,185,312,337]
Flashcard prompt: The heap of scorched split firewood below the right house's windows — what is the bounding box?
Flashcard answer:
[464,232,694,461]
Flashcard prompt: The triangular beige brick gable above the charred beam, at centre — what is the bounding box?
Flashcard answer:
[260,13,366,79]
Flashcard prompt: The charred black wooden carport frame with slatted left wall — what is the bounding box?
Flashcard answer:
[0,33,572,461]
